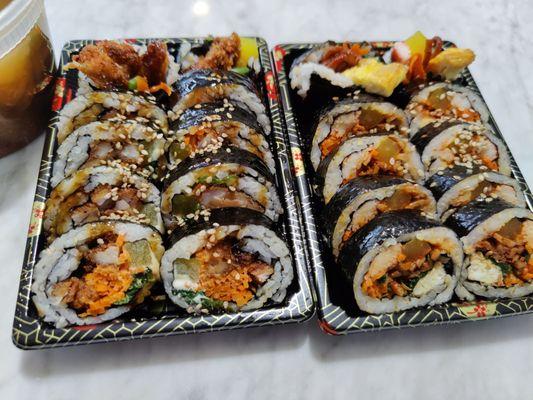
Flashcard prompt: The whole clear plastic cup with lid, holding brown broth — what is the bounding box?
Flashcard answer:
[0,0,55,157]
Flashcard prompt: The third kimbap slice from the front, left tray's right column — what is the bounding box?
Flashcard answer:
[167,99,275,173]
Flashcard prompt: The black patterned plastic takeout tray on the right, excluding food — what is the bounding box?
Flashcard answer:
[272,42,533,335]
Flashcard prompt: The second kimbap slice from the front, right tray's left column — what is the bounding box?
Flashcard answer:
[324,175,435,257]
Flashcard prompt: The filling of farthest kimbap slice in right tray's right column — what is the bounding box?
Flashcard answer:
[413,87,481,122]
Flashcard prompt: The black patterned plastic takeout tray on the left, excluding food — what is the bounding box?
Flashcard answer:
[13,38,314,349]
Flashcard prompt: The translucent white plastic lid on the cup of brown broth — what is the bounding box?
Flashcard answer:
[0,0,44,57]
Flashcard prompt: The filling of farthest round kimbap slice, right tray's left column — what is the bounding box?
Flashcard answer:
[320,107,402,159]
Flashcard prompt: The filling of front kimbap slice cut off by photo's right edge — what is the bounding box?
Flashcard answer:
[468,218,533,287]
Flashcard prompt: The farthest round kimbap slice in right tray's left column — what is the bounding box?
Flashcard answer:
[311,95,409,170]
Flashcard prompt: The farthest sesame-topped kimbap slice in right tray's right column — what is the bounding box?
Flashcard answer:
[406,82,490,134]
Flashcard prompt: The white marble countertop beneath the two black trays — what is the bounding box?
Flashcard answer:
[0,0,533,400]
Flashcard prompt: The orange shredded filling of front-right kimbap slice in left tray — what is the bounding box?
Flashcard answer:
[174,236,274,307]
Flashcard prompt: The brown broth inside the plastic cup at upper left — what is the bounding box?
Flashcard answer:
[0,9,55,157]
